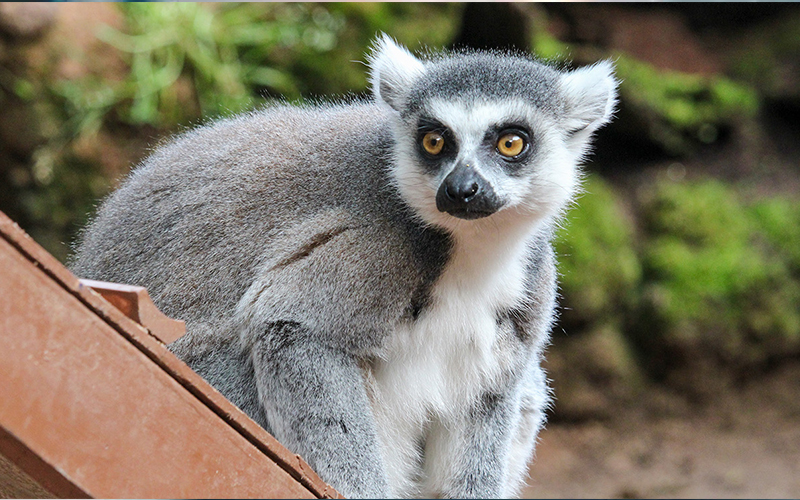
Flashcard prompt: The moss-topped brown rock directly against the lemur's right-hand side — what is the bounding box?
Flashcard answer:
[554,175,642,398]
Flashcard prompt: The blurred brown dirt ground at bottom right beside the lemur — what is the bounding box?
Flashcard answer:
[523,363,800,498]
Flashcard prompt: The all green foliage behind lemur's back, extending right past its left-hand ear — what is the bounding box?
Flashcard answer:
[52,2,457,138]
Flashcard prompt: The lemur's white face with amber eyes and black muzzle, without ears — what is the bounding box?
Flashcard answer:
[395,98,577,224]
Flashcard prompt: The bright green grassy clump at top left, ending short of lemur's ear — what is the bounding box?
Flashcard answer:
[54,2,344,132]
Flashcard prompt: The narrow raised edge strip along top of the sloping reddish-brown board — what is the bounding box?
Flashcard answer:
[0,211,344,498]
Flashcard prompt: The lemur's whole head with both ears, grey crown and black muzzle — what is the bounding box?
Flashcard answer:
[370,35,617,234]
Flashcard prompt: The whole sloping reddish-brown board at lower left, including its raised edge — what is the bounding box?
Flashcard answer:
[0,213,338,498]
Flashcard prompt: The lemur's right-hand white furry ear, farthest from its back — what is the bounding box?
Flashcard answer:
[561,61,619,136]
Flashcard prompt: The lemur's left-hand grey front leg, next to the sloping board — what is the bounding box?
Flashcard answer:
[252,322,388,498]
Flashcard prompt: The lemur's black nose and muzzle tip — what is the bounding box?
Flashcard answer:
[436,165,500,219]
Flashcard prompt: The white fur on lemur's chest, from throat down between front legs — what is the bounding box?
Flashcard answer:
[369,219,540,496]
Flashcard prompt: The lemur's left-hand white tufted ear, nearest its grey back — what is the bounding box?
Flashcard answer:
[369,33,425,111]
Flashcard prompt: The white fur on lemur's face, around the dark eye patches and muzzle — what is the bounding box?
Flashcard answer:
[394,101,580,237]
